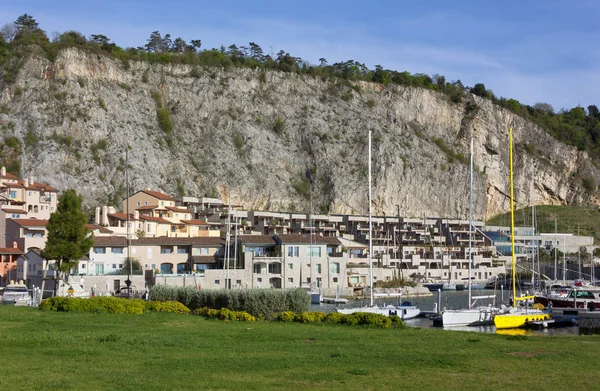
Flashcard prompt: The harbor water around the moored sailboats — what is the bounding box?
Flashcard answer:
[311,290,579,335]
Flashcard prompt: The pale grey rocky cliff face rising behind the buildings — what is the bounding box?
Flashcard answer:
[0,49,599,219]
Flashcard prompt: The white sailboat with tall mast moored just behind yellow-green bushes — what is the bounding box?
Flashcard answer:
[337,130,421,319]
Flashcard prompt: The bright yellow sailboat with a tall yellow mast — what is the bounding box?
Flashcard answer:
[494,128,550,330]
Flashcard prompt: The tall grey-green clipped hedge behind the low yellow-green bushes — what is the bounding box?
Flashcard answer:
[150,285,310,320]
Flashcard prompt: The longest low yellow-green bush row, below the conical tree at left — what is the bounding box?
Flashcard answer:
[40,296,190,314]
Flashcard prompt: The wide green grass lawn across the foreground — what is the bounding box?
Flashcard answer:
[0,306,600,390]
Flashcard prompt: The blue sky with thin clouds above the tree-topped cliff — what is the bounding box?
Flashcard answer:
[0,0,600,111]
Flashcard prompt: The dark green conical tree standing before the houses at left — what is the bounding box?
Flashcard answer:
[41,189,94,292]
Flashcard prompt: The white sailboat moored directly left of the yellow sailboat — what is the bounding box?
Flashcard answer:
[442,138,499,327]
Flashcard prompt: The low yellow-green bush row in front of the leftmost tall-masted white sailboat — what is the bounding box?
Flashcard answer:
[276,311,404,329]
